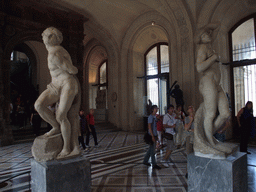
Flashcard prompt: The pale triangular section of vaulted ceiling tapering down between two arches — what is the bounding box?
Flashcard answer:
[57,0,161,42]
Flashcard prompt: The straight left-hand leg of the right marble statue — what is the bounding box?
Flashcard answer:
[200,80,217,145]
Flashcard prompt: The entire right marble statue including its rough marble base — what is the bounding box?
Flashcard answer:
[194,23,235,158]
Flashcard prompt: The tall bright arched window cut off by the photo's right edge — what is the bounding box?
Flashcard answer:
[230,14,256,115]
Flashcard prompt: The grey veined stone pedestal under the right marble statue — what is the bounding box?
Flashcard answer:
[187,152,248,192]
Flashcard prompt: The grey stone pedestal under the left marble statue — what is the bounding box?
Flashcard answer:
[31,157,91,192]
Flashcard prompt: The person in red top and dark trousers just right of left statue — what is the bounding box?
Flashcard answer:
[86,109,98,147]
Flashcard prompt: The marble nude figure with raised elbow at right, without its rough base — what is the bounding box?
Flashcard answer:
[195,23,230,152]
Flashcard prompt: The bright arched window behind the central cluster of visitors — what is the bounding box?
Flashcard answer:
[145,43,169,114]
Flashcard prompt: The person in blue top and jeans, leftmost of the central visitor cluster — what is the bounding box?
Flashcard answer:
[143,105,161,169]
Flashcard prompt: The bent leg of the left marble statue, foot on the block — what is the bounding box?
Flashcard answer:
[35,89,60,136]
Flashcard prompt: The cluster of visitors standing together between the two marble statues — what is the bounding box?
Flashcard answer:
[143,105,195,169]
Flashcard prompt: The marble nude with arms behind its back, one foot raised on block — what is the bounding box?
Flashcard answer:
[35,27,79,158]
